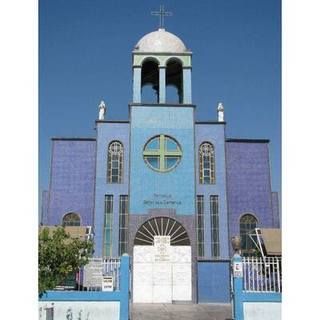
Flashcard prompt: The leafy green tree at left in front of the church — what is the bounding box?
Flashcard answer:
[38,227,93,296]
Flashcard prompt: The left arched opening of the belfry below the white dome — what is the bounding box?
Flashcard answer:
[141,60,159,103]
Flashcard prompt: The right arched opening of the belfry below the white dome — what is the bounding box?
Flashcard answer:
[166,58,183,103]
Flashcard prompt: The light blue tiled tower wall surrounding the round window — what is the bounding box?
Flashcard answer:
[130,106,195,215]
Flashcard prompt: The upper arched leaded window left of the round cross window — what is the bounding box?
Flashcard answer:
[107,141,123,183]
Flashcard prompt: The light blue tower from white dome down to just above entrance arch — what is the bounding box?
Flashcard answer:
[129,25,195,215]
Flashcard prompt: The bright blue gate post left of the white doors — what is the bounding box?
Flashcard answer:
[120,253,130,320]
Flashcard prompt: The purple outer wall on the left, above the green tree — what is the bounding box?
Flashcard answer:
[44,138,96,226]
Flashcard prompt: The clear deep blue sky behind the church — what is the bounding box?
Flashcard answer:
[39,0,281,191]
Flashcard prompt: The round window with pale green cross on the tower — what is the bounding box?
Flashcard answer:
[143,134,182,172]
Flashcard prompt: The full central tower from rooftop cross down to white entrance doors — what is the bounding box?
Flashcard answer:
[129,17,196,303]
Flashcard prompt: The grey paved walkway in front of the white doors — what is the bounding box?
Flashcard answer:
[131,303,232,320]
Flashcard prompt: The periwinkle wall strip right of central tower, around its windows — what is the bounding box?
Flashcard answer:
[195,123,229,259]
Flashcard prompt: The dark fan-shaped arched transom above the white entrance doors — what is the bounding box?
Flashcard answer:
[134,217,190,246]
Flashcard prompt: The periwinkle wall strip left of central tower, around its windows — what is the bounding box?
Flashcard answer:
[94,122,129,256]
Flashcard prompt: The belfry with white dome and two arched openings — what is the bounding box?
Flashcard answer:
[132,26,192,105]
